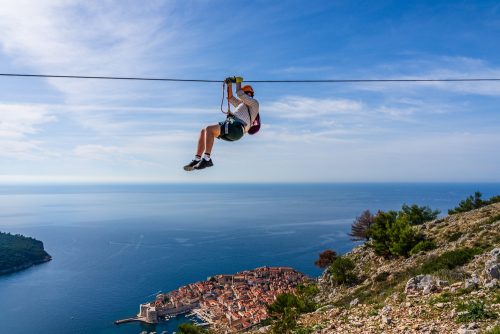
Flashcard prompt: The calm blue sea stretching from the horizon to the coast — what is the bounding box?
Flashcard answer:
[0,183,500,334]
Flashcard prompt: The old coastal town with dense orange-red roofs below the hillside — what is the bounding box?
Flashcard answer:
[138,267,310,330]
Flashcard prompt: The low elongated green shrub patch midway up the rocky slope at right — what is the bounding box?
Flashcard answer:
[419,247,483,274]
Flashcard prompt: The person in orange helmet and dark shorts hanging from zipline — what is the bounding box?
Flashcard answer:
[184,77,260,171]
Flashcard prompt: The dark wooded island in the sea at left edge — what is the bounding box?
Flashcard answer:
[0,232,52,275]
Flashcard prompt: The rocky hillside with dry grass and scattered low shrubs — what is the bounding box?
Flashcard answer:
[257,203,500,334]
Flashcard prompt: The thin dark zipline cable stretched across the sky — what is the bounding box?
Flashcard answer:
[0,73,500,83]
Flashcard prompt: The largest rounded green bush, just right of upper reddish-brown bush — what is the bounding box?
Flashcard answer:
[369,211,424,257]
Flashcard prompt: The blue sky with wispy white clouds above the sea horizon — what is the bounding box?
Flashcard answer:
[0,0,500,183]
